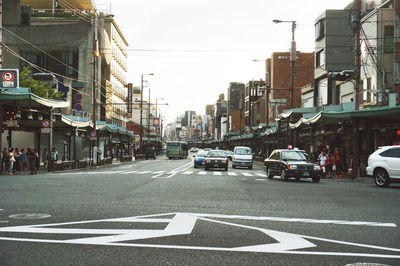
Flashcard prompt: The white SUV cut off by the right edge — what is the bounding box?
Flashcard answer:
[367,146,400,187]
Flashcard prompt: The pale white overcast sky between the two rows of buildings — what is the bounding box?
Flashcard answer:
[96,0,351,122]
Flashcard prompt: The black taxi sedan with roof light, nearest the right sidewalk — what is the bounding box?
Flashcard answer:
[264,149,322,183]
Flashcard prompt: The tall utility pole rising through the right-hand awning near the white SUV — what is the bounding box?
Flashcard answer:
[351,0,361,178]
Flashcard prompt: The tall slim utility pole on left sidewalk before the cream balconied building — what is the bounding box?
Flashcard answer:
[92,9,100,165]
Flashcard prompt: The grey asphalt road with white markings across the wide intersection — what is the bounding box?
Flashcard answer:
[0,157,400,265]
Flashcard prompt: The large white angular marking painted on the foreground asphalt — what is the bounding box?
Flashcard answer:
[0,213,400,259]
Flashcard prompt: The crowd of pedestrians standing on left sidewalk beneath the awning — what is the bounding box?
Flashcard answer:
[1,147,58,175]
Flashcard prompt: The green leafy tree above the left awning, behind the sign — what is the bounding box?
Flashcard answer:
[19,67,63,100]
